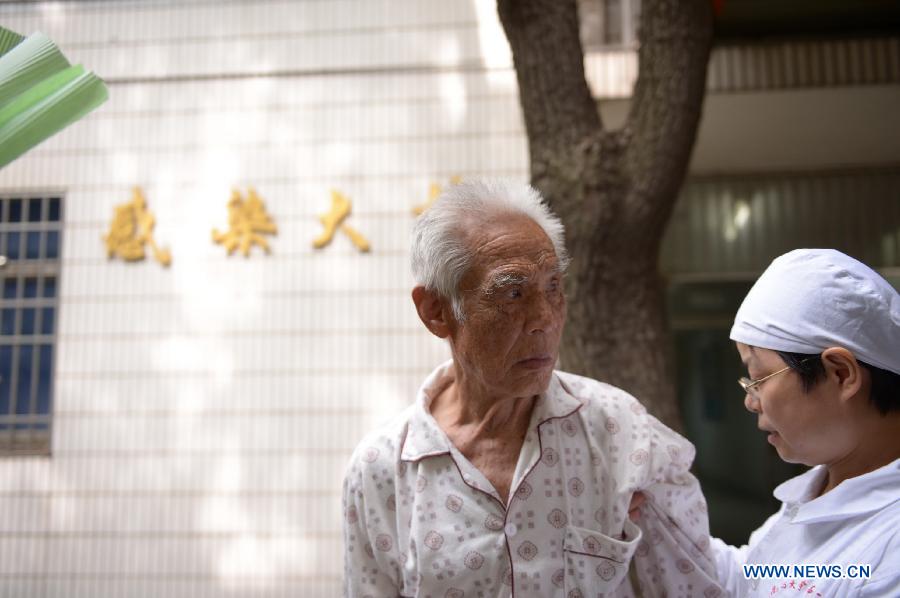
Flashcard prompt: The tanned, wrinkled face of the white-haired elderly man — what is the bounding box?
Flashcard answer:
[450,214,566,397]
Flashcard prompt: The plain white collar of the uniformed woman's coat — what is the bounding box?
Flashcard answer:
[774,459,900,523]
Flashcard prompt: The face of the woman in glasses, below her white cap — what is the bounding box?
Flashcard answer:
[737,343,853,465]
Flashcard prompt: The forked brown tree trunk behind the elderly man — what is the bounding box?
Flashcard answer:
[497,0,712,429]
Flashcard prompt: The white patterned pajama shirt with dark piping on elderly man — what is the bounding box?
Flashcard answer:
[343,362,724,598]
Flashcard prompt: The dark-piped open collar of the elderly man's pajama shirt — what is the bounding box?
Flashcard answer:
[400,359,583,461]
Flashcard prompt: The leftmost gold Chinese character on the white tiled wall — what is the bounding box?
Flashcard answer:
[103,187,172,266]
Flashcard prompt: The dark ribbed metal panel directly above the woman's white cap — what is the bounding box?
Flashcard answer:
[661,169,900,279]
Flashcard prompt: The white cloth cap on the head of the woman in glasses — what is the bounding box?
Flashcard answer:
[731,249,900,374]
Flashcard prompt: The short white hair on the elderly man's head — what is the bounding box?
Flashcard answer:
[412,180,569,322]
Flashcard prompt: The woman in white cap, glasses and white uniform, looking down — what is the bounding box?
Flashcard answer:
[712,249,900,597]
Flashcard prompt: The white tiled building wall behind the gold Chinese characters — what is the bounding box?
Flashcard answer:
[0,0,527,598]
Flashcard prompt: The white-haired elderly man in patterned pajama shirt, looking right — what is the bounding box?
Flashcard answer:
[344,182,720,598]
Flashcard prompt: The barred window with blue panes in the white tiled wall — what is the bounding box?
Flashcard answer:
[0,195,62,455]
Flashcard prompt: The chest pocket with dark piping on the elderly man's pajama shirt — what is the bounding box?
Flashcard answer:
[563,519,641,598]
